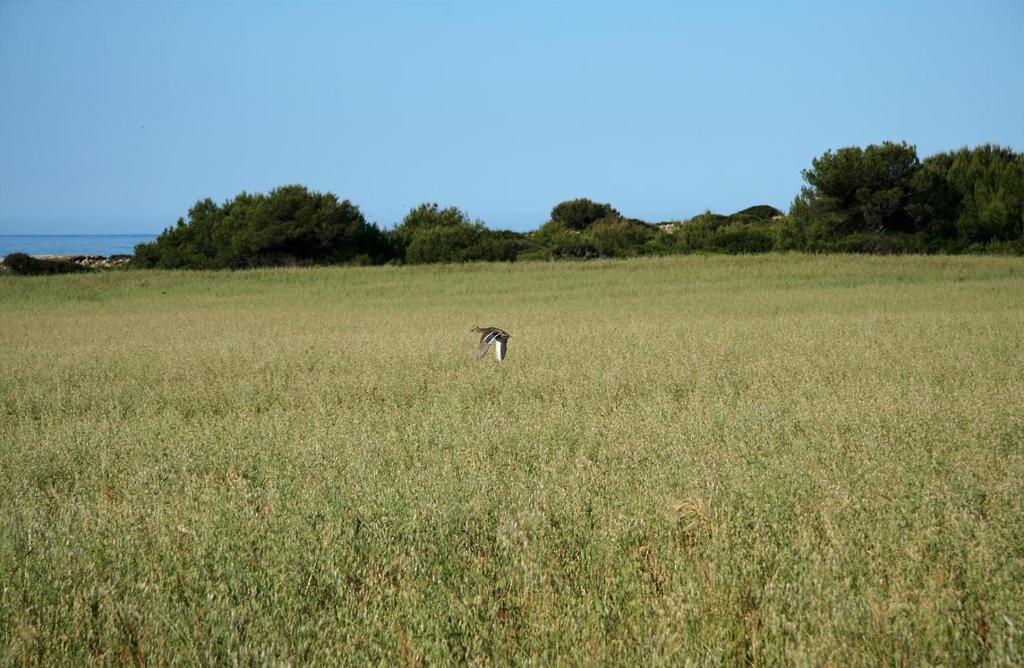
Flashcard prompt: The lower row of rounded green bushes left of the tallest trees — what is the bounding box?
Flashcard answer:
[132,185,784,268]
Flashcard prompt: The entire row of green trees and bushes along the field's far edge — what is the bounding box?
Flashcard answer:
[8,141,1024,273]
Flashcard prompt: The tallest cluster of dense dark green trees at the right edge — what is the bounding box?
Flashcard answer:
[787,141,1024,252]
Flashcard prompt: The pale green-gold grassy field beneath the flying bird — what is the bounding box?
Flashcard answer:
[0,256,1024,666]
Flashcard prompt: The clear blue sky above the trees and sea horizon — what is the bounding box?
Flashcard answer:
[0,0,1024,234]
